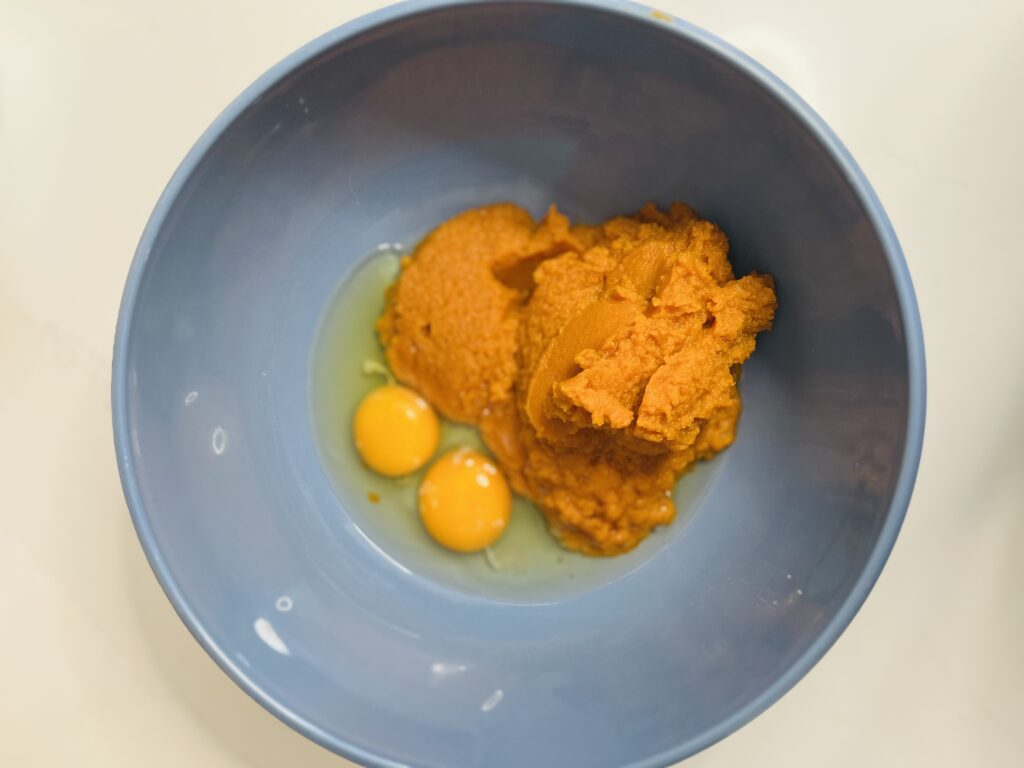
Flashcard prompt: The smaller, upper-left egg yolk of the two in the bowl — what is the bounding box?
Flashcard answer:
[352,384,440,477]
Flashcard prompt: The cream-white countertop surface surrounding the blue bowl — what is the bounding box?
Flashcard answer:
[0,0,1024,768]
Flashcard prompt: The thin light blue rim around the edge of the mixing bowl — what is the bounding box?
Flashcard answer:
[111,0,927,768]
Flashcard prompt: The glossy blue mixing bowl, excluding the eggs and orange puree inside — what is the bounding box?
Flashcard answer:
[113,0,925,768]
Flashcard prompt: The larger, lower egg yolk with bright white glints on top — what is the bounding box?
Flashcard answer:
[420,449,512,552]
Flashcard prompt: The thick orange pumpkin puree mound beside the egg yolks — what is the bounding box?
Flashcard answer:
[378,203,776,555]
